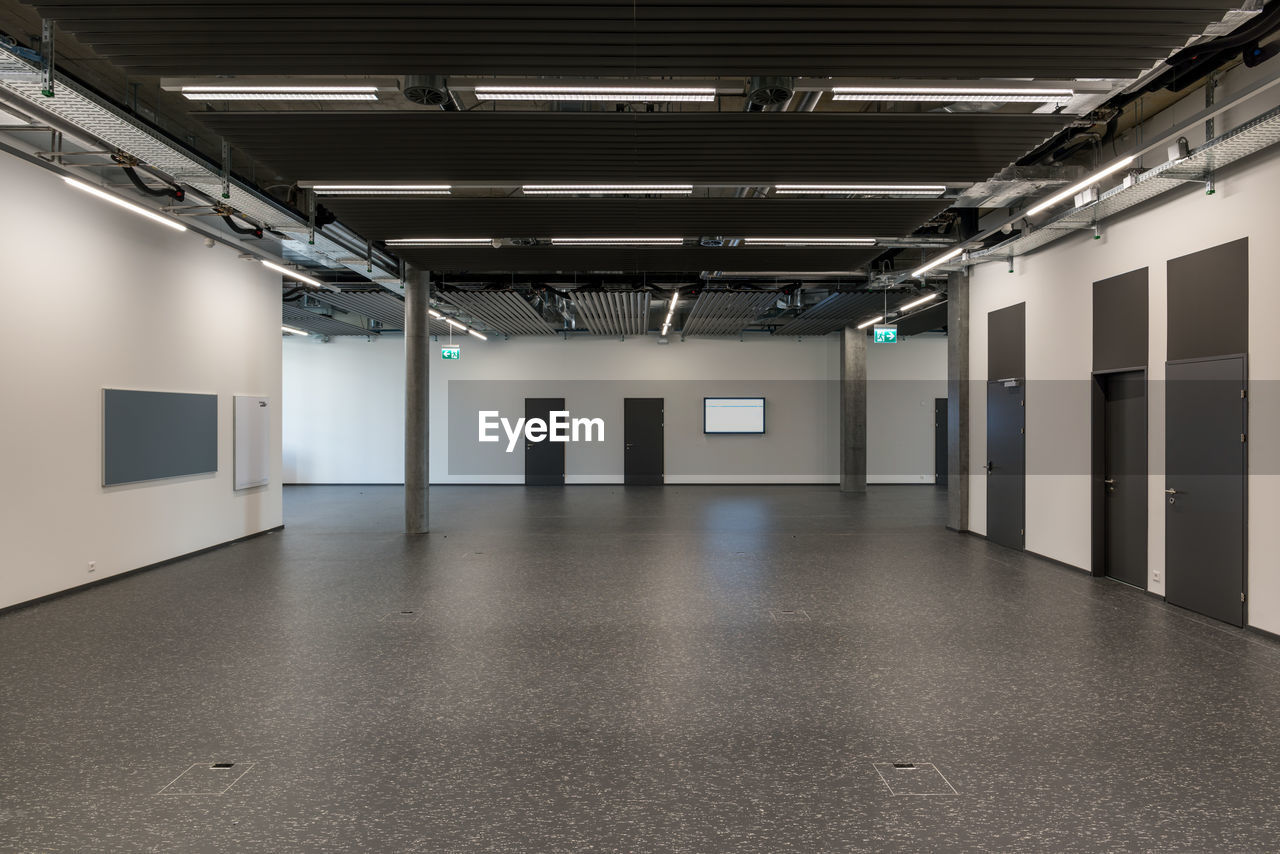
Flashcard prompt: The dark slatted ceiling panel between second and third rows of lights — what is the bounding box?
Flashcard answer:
[314,197,948,239]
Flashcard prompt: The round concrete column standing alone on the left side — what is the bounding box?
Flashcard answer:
[404,268,431,534]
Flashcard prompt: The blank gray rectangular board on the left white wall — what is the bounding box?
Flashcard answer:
[102,388,218,487]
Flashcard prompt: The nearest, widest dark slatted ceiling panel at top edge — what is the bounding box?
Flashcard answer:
[35,0,1240,77]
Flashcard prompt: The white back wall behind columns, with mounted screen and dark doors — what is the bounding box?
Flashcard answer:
[284,335,946,483]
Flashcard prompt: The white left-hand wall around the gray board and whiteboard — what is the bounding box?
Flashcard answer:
[0,154,282,607]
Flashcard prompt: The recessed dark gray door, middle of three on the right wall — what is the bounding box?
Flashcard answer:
[1100,371,1147,589]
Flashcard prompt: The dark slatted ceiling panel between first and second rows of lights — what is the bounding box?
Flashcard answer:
[195,111,1069,186]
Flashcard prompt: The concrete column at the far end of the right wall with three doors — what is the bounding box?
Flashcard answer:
[947,273,969,531]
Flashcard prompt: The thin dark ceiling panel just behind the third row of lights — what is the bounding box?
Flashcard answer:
[396,246,881,274]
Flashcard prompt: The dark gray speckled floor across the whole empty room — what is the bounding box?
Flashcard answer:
[0,487,1280,854]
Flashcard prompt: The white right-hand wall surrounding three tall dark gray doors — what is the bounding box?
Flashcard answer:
[969,68,1280,632]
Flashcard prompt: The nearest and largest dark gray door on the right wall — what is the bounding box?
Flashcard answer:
[1165,356,1248,626]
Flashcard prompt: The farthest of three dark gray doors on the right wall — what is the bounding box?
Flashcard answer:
[987,379,1027,548]
